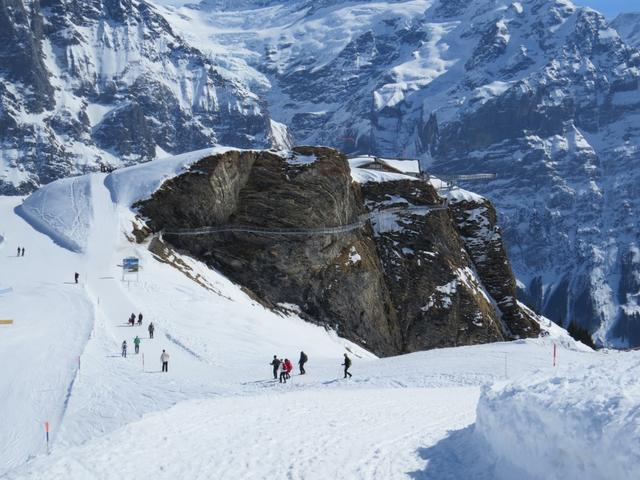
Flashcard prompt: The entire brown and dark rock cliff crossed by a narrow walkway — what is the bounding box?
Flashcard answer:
[136,147,538,355]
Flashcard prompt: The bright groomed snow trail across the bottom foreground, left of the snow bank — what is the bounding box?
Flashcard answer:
[10,388,477,480]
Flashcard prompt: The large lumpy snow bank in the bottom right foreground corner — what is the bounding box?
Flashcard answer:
[476,354,640,480]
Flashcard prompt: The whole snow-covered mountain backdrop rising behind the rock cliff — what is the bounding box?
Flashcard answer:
[0,0,640,345]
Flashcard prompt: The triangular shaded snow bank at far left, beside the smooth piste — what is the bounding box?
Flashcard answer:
[16,175,93,252]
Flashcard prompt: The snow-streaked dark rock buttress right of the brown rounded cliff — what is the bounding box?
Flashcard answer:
[362,181,509,352]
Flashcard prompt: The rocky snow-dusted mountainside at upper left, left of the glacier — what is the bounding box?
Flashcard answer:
[0,0,282,193]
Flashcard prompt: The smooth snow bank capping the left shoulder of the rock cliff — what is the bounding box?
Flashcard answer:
[105,146,239,206]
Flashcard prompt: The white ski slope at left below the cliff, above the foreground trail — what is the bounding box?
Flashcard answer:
[0,156,372,475]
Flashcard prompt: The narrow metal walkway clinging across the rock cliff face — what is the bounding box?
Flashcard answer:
[160,202,448,236]
